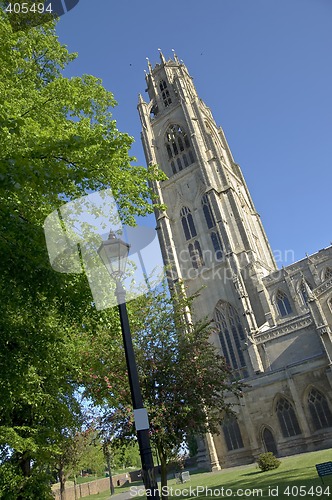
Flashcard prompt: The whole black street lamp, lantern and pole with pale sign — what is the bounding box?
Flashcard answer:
[98,231,159,500]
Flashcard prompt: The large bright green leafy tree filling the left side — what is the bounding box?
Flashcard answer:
[0,11,165,500]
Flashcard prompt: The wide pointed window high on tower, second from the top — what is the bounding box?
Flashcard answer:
[165,125,195,173]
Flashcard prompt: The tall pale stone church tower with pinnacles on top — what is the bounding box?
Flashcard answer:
[138,52,276,378]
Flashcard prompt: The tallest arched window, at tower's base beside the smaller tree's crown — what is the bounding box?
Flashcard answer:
[214,301,248,378]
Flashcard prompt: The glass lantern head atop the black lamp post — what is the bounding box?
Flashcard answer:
[98,230,130,280]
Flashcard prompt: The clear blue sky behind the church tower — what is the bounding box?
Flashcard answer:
[57,0,332,265]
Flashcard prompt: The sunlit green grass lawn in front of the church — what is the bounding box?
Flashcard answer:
[90,449,332,500]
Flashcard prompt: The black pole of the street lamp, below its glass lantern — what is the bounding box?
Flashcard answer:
[115,280,159,500]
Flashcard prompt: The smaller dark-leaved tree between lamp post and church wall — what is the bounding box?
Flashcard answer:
[97,286,241,498]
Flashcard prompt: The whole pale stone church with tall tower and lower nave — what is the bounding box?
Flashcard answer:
[138,52,332,469]
